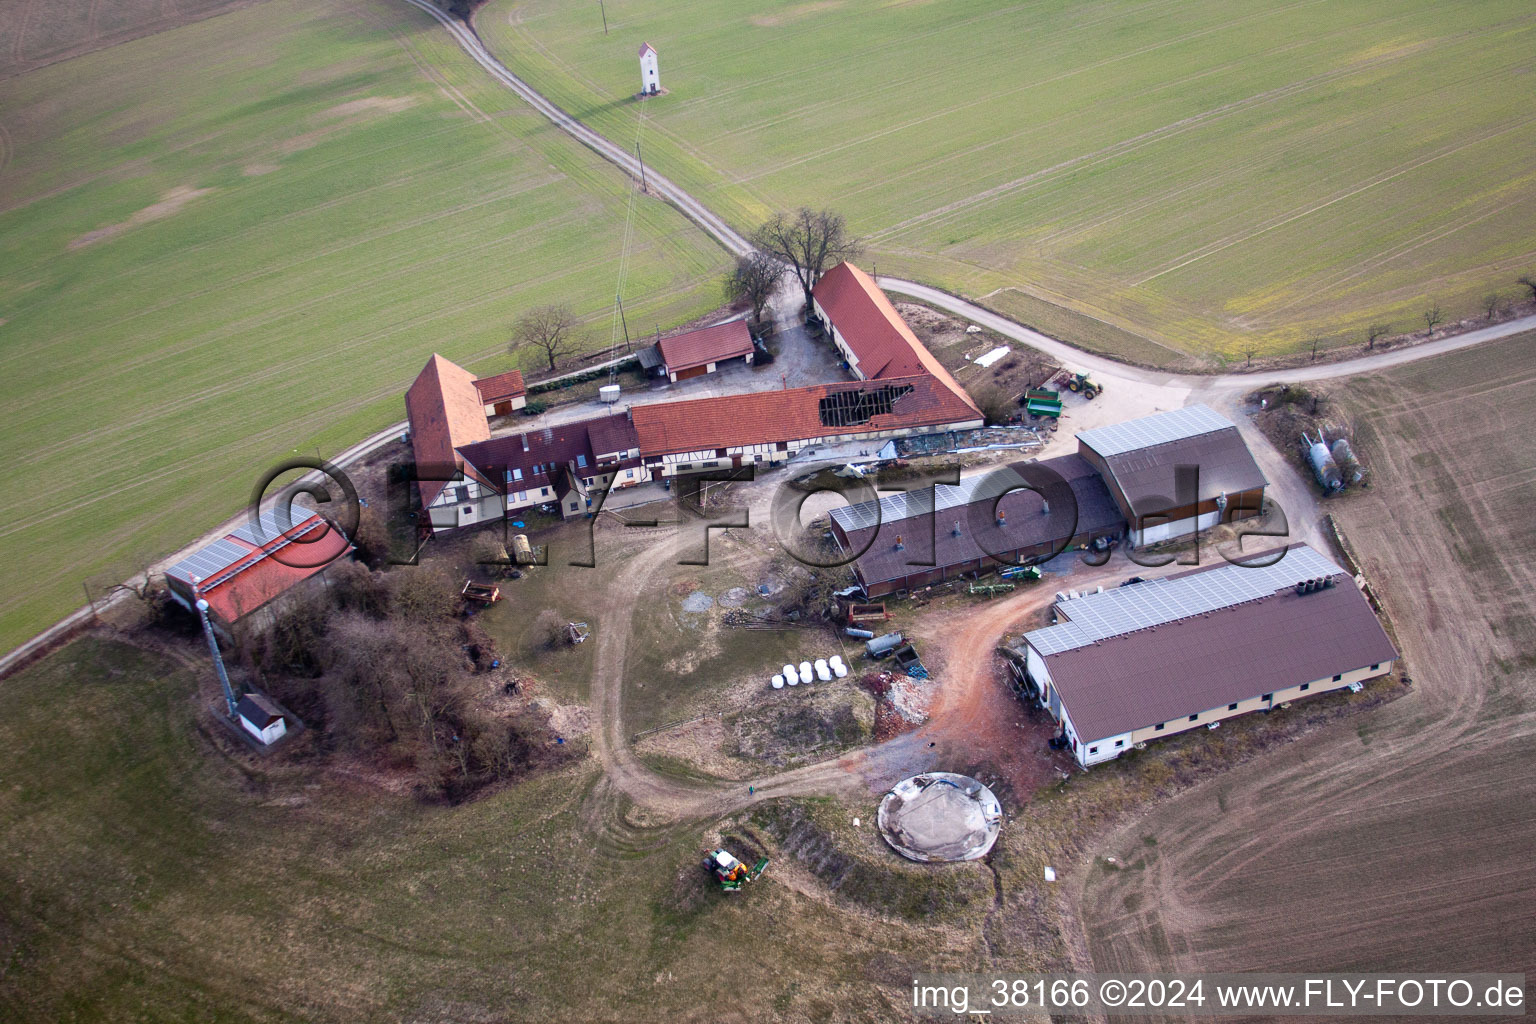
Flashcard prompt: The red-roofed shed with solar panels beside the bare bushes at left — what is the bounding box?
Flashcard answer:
[166,505,352,639]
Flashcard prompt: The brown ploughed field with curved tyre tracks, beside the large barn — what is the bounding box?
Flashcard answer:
[1083,333,1536,994]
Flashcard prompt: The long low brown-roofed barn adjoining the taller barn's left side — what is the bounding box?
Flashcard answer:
[831,454,1126,597]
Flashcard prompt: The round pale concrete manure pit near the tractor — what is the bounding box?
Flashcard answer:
[876,772,1003,863]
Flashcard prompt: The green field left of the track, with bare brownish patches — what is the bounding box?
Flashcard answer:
[0,0,727,648]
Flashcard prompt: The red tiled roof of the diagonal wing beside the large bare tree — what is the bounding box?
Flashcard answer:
[813,263,980,413]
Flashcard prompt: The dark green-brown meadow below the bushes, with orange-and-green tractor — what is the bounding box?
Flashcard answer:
[0,639,992,1024]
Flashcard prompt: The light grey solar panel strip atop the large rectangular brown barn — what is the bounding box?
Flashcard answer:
[1025,545,1344,656]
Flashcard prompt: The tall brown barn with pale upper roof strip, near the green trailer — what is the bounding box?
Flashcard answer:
[1077,405,1266,547]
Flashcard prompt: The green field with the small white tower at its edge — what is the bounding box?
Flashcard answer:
[476,0,1536,364]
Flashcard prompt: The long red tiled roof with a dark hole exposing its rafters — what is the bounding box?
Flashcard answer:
[630,375,982,457]
